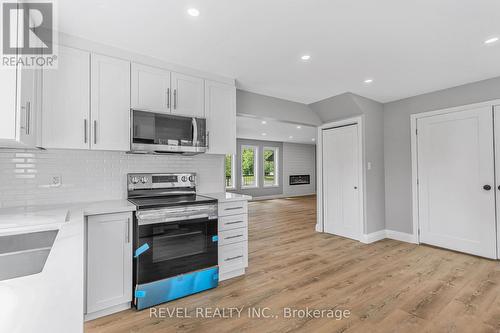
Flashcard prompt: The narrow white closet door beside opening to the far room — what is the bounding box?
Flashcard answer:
[322,124,362,240]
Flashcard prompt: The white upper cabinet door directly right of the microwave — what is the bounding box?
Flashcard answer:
[205,81,236,154]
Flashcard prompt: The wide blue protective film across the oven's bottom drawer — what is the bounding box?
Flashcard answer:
[136,266,219,310]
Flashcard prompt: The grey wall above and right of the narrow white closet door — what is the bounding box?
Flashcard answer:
[309,93,385,233]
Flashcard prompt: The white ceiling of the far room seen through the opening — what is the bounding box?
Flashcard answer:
[236,116,317,144]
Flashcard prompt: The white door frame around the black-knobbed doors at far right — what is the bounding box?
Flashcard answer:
[410,99,500,244]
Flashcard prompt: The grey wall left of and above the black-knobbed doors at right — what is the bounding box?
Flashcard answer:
[384,77,500,233]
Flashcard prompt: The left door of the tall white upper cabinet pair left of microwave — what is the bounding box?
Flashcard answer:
[42,46,90,149]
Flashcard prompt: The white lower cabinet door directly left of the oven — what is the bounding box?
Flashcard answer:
[86,213,132,313]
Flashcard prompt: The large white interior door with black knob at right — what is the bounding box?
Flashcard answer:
[417,107,496,258]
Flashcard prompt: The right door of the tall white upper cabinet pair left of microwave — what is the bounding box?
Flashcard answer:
[90,54,130,151]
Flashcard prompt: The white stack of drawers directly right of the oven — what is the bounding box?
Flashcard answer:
[218,201,248,281]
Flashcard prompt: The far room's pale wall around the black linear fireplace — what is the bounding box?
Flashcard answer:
[283,142,316,196]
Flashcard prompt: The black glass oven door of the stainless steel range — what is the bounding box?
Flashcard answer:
[134,209,218,284]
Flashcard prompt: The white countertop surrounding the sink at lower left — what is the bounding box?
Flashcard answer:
[0,209,84,333]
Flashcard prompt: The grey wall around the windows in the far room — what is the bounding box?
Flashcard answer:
[229,139,284,197]
